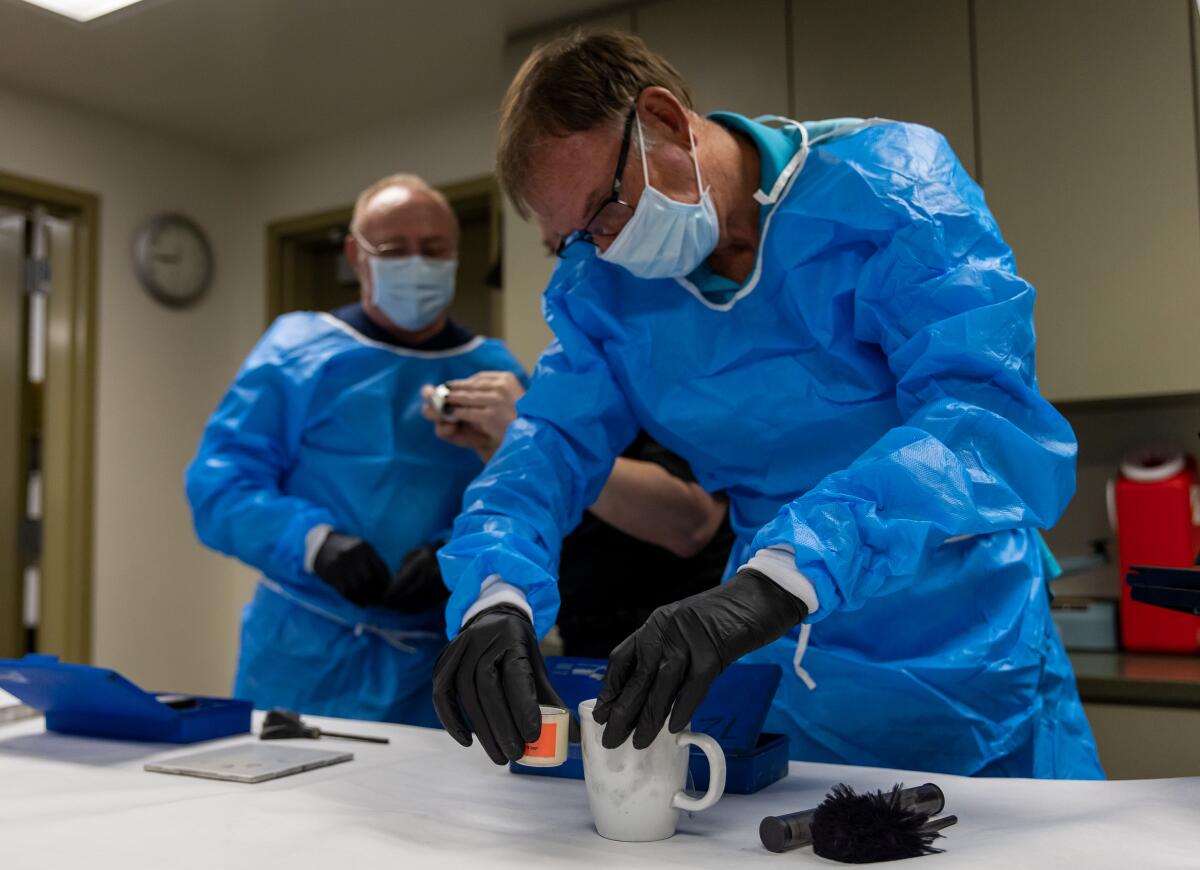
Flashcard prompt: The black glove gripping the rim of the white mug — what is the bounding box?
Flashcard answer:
[593,569,809,749]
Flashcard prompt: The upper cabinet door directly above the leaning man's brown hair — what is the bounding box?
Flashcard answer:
[634,0,790,118]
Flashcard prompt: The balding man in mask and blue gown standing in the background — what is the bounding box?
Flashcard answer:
[187,175,524,726]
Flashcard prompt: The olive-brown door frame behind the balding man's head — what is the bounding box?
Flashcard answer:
[265,175,504,337]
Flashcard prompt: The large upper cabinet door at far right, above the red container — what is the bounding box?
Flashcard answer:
[976,0,1200,400]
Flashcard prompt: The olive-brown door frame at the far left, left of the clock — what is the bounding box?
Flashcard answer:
[0,172,100,662]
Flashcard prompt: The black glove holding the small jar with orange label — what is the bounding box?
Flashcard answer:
[433,604,565,764]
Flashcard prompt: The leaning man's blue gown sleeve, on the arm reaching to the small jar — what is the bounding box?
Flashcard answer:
[438,288,638,637]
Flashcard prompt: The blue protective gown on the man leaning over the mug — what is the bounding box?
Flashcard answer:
[440,116,1103,778]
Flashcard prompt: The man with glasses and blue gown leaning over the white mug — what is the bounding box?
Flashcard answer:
[433,34,1103,778]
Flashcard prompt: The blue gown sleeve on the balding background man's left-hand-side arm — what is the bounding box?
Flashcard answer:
[186,322,335,582]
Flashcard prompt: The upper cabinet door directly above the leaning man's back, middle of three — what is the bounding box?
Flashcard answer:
[792,0,976,173]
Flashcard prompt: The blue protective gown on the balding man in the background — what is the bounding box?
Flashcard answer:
[187,312,524,726]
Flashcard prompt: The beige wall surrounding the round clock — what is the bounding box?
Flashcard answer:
[0,81,258,691]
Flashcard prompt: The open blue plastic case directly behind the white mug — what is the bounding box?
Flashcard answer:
[509,655,788,794]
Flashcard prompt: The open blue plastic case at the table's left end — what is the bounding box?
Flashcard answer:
[0,654,253,743]
